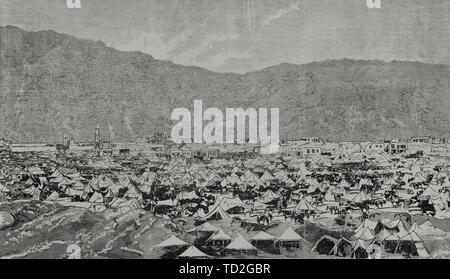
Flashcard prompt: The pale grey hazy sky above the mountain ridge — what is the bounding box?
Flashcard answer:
[0,0,450,72]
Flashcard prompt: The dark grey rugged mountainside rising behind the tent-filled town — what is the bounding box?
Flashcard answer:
[0,26,450,141]
